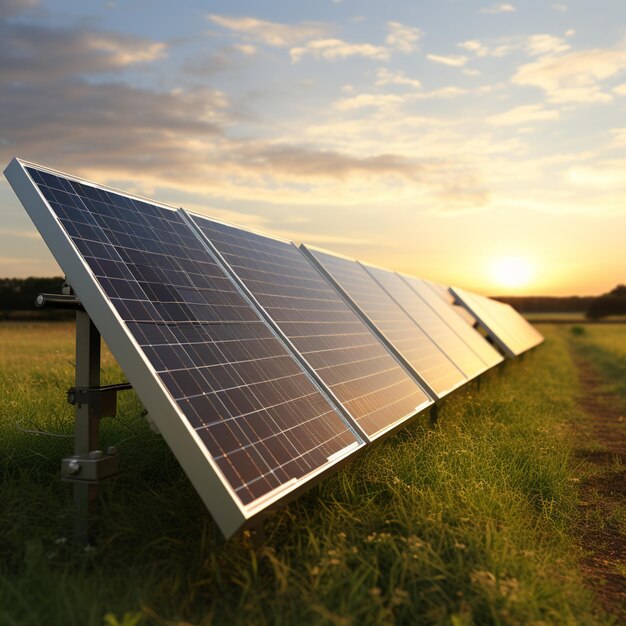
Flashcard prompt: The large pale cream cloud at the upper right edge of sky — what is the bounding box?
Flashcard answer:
[512,48,626,103]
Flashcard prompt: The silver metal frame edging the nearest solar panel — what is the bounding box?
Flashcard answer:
[4,158,365,539]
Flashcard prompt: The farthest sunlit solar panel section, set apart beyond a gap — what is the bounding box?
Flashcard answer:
[451,287,543,357]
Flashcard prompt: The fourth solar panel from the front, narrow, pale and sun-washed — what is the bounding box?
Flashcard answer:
[361,263,488,379]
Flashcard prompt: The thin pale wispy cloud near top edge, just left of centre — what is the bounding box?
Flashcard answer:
[206,14,329,48]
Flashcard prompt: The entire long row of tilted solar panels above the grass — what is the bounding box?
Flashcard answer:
[5,159,541,536]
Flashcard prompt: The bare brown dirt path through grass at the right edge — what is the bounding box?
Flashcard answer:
[574,353,626,624]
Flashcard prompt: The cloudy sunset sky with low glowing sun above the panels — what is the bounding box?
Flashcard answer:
[0,0,626,295]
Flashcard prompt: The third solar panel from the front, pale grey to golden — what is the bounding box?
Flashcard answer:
[301,244,467,397]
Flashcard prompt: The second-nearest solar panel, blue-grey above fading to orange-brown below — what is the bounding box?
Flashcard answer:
[185,214,432,438]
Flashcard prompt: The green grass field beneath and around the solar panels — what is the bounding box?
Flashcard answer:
[0,323,626,626]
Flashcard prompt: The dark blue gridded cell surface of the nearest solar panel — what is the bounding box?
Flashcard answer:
[27,167,356,505]
